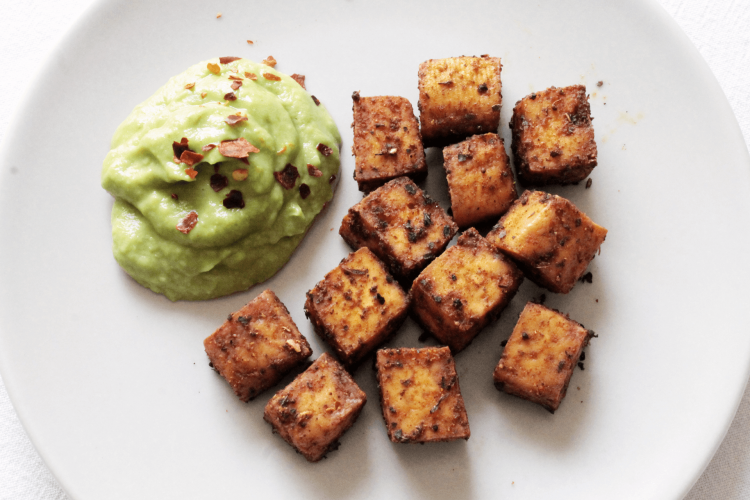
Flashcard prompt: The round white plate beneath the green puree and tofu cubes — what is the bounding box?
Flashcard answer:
[0,0,750,500]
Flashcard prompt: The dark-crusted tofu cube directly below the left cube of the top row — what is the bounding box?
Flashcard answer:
[339,177,458,282]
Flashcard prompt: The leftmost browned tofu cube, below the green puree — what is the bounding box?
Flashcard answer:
[203,290,312,401]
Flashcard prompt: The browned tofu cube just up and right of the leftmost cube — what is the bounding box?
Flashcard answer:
[305,247,409,369]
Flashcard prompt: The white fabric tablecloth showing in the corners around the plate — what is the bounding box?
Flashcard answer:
[0,0,750,500]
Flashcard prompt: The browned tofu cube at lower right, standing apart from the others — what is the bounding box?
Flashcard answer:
[493,302,594,413]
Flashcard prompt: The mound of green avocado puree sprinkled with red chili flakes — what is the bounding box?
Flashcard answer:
[102,59,341,300]
